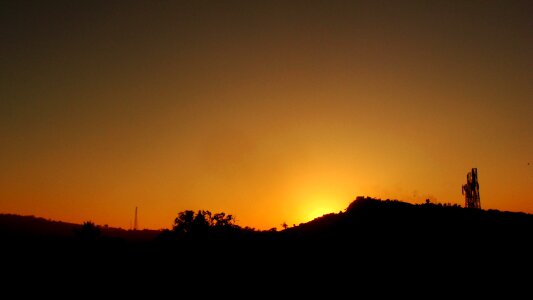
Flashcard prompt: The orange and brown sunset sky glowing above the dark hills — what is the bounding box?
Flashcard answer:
[0,0,533,229]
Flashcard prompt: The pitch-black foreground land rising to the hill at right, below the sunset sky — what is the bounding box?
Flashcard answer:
[1,199,533,292]
